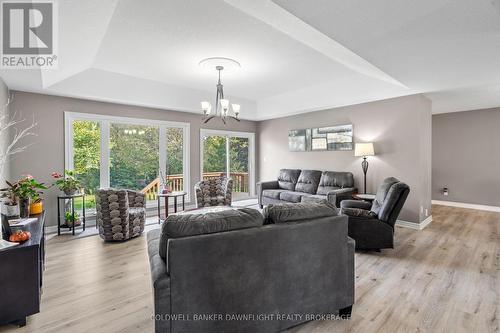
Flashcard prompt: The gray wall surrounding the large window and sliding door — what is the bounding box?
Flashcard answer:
[10,91,257,225]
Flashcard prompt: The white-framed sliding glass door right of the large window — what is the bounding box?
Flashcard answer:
[200,129,255,200]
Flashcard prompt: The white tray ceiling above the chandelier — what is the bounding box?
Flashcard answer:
[0,0,500,120]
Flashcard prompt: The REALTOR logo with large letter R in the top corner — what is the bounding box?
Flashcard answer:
[1,1,57,69]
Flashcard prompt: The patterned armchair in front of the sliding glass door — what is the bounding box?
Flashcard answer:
[194,176,233,208]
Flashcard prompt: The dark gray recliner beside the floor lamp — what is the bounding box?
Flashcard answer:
[340,177,410,250]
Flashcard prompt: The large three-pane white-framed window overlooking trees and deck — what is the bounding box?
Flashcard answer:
[65,112,190,214]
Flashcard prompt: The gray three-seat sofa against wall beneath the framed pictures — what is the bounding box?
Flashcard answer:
[257,169,357,208]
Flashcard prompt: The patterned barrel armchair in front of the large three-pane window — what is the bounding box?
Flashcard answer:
[96,189,146,241]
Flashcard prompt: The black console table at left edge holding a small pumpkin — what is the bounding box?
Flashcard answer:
[0,212,45,326]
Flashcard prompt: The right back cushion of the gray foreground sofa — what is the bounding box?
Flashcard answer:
[262,200,338,223]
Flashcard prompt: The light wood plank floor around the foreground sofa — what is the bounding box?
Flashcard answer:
[0,206,500,333]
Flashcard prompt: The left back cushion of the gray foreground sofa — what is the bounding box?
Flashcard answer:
[159,207,264,260]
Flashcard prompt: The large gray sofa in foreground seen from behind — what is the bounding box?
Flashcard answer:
[147,204,354,333]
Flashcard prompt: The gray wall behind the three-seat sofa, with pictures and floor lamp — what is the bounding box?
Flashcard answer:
[257,95,432,222]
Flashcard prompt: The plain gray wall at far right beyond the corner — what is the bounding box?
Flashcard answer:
[432,108,500,206]
